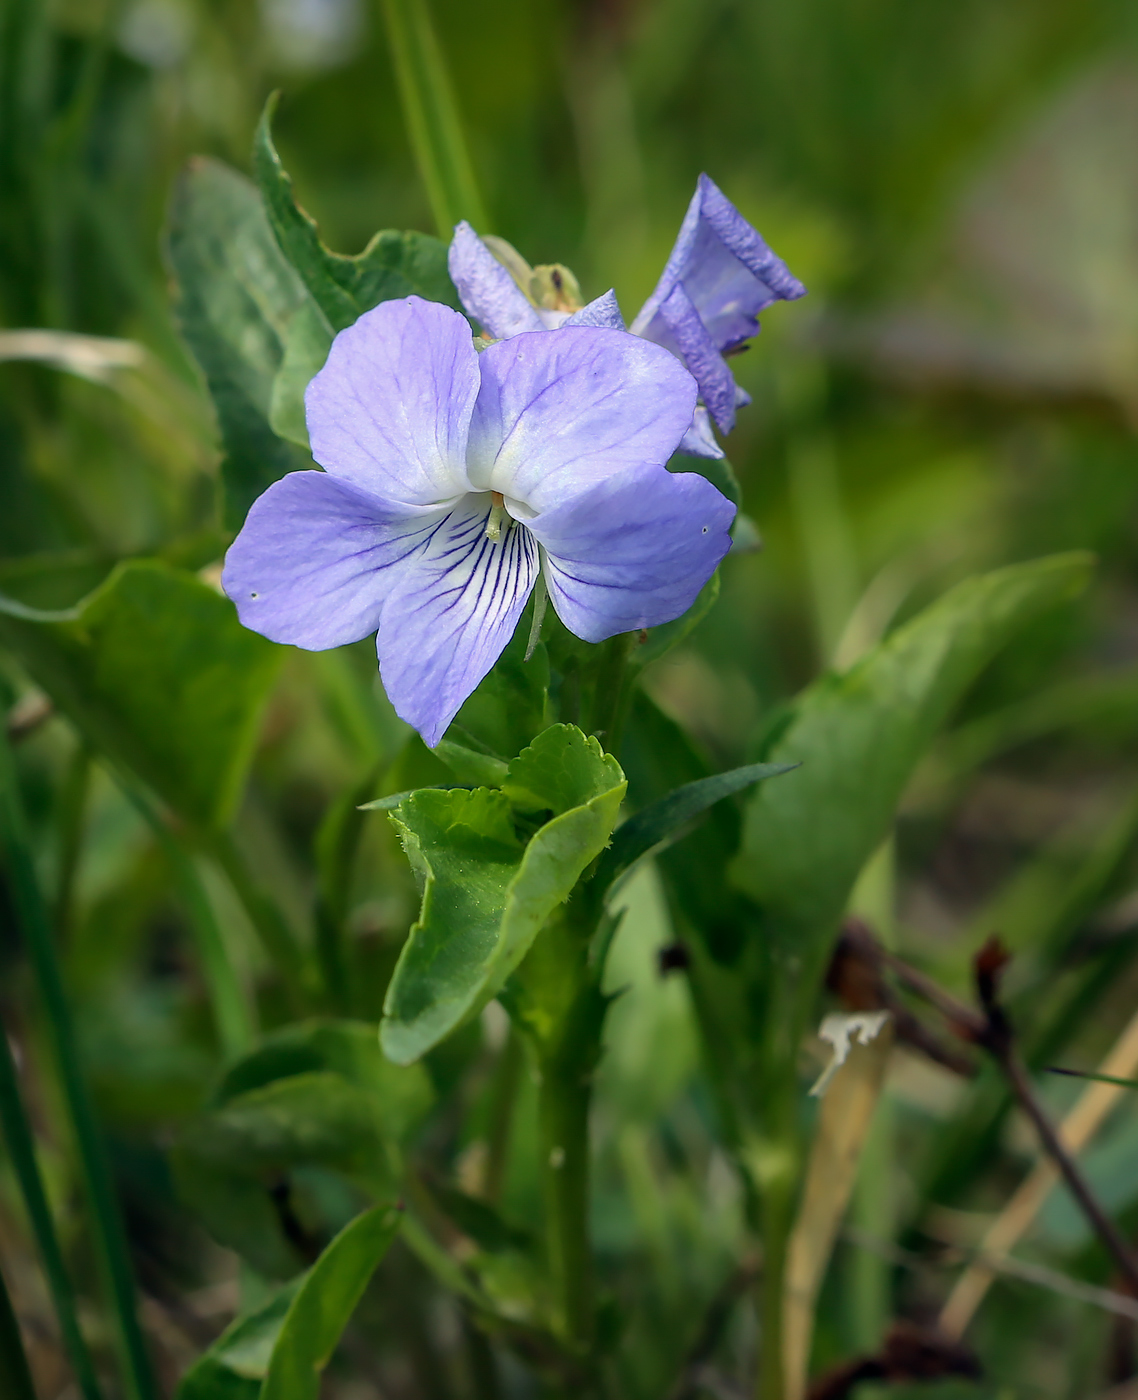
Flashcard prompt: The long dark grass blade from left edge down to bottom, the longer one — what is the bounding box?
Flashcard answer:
[0,735,158,1400]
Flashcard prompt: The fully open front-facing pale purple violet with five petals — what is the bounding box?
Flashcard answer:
[223,297,735,745]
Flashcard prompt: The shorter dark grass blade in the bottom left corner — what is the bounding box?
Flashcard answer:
[0,1025,102,1400]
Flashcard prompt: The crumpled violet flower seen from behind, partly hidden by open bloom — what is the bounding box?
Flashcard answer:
[449,175,806,456]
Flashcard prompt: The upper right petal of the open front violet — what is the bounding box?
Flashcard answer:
[468,326,696,519]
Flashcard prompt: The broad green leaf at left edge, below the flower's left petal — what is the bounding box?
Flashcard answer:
[0,561,281,830]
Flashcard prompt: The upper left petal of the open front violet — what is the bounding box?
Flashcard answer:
[304,297,479,507]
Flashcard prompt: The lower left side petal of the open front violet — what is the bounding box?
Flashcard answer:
[221,472,442,651]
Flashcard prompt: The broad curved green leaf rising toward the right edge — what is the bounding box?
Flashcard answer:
[732,553,1093,939]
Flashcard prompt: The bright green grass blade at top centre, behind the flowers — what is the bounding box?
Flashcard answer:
[384,0,490,242]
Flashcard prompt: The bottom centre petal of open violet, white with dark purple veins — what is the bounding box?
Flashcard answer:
[378,497,538,748]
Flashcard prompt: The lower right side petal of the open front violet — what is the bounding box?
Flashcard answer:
[529,466,735,641]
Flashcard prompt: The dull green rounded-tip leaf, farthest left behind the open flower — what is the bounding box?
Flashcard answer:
[167,157,311,529]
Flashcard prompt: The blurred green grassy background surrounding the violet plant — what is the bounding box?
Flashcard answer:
[0,0,1138,1400]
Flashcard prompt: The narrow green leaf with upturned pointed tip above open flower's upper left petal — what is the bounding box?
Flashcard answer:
[253,94,458,333]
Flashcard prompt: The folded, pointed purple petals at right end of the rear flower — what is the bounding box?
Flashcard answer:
[633,175,806,350]
